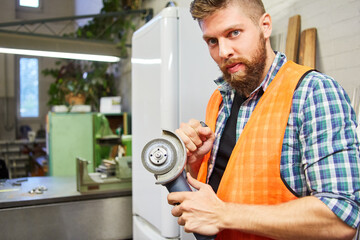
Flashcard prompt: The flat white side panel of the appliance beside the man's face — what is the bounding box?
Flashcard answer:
[179,8,221,122]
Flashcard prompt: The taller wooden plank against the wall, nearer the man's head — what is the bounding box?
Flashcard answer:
[285,15,301,62]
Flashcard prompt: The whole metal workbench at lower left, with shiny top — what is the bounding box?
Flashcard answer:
[0,177,132,240]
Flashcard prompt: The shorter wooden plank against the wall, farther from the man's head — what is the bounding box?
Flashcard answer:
[299,28,317,68]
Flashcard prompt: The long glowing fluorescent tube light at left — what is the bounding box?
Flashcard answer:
[0,48,120,62]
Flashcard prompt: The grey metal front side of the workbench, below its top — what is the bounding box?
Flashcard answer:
[0,196,132,240]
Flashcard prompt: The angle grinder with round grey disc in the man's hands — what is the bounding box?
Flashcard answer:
[141,130,215,240]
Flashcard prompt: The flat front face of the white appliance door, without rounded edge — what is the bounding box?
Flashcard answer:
[132,9,165,236]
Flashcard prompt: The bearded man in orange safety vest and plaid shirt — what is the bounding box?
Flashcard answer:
[168,0,360,240]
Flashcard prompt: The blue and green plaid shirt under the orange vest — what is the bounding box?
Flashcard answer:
[208,53,360,228]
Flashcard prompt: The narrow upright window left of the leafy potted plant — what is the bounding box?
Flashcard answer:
[19,57,39,118]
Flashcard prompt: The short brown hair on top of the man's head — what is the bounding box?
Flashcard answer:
[190,0,265,23]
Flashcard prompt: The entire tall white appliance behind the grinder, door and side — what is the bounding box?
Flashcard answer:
[132,7,220,240]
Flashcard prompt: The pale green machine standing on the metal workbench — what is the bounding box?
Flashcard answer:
[48,113,132,193]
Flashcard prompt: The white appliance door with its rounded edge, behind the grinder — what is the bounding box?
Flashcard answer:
[132,8,180,240]
